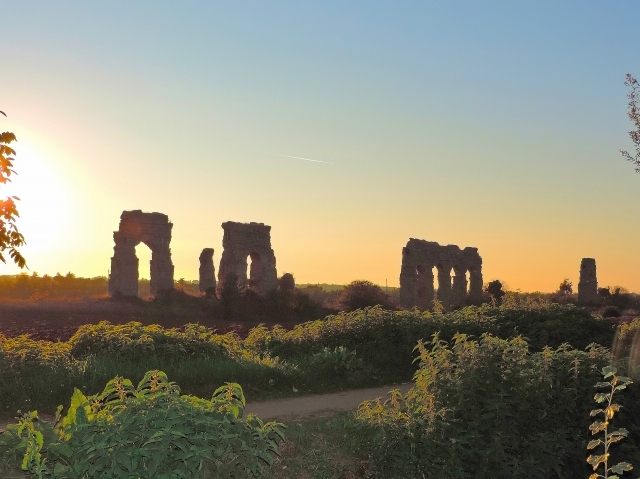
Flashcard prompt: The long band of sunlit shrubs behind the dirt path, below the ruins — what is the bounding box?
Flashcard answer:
[0,304,630,420]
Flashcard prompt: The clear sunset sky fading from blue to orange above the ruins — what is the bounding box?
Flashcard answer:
[0,0,640,291]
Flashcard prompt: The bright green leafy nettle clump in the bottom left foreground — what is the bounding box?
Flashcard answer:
[0,371,284,479]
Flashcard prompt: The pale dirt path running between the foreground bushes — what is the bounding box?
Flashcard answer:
[0,383,412,432]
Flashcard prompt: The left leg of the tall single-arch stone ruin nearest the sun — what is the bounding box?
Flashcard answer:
[109,231,138,296]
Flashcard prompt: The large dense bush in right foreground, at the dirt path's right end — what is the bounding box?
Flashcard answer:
[358,334,640,479]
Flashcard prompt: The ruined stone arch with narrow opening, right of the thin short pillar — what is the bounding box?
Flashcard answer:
[218,221,278,293]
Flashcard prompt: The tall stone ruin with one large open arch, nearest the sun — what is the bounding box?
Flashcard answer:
[109,210,174,296]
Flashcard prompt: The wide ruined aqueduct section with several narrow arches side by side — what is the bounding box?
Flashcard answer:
[400,238,482,310]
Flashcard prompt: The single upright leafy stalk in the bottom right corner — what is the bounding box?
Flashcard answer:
[587,366,633,479]
